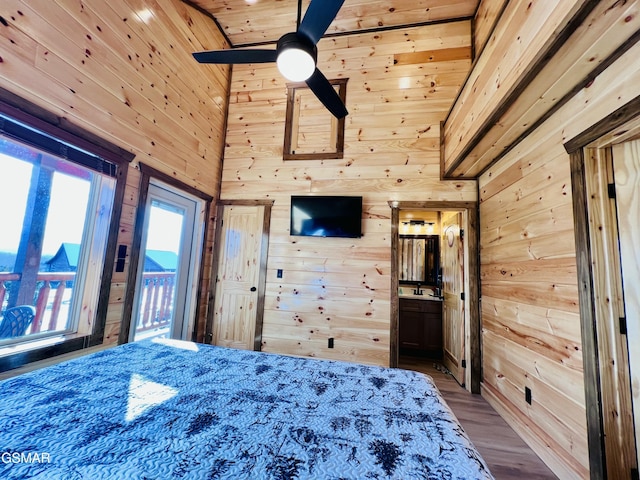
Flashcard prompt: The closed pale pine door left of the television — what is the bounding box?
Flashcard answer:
[213,205,266,350]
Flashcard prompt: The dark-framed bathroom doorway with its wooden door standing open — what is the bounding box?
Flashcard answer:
[389,202,481,393]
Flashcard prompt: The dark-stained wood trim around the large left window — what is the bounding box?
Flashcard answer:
[0,88,134,372]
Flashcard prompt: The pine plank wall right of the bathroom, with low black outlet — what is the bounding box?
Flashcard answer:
[479,21,640,478]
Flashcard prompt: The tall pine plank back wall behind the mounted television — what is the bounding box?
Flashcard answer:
[221,21,477,365]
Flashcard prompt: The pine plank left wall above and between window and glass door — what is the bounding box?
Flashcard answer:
[0,0,229,343]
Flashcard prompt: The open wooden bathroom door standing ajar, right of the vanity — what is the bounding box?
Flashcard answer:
[440,212,465,385]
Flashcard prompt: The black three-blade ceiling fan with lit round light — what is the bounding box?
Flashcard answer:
[193,0,348,118]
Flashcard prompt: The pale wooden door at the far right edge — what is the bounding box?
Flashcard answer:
[607,140,640,472]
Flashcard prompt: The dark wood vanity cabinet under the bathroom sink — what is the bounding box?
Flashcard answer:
[399,298,442,359]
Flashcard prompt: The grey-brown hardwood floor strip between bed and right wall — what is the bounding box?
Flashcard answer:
[399,356,557,480]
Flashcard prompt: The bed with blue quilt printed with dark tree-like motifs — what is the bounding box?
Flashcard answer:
[0,339,493,480]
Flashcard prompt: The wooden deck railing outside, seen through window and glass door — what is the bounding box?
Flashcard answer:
[0,272,175,335]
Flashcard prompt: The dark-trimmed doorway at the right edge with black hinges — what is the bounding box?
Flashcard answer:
[565,103,640,478]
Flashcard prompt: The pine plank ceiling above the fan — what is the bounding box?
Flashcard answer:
[184,0,480,47]
